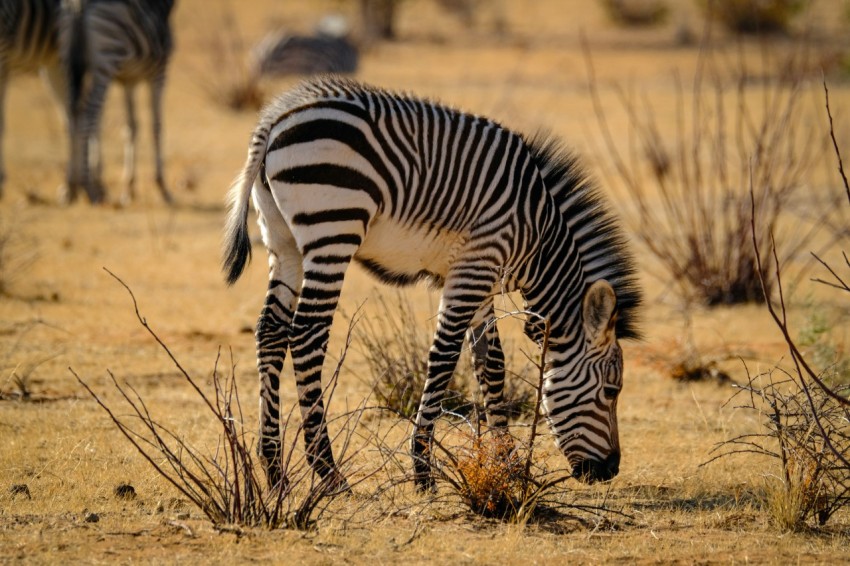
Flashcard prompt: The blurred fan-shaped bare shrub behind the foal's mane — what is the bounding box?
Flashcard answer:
[586,40,830,306]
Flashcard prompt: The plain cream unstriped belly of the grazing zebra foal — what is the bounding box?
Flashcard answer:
[354,217,467,286]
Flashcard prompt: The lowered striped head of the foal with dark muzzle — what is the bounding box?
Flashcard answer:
[543,280,623,483]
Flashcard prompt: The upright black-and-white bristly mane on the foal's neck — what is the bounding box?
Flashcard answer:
[525,133,642,339]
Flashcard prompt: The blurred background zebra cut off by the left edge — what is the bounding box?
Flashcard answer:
[0,0,66,200]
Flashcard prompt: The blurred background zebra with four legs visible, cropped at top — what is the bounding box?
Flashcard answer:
[65,0,174,204]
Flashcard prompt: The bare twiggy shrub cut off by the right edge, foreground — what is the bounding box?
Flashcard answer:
[715,83,850,530]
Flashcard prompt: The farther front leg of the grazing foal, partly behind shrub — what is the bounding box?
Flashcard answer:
[467,312,508,429]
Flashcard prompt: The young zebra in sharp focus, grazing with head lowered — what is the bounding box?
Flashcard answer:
[223,77,640,488]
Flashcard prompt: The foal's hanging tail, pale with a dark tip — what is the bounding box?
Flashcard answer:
[222,126,269,285]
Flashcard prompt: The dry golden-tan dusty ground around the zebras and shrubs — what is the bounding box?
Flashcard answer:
[0,0,850,564]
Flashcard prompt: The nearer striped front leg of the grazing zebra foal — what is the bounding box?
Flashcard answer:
[411,260,497,490]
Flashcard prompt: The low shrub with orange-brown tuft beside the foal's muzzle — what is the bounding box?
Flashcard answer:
[348,312,623,528]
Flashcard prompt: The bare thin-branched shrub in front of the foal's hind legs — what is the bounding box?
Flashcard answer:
[71,273,363,529]
